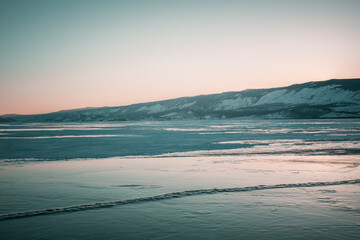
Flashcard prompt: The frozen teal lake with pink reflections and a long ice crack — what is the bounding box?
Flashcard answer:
[0,119,360,239]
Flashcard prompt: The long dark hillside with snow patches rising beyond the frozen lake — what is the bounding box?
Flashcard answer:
[0,79,360,122]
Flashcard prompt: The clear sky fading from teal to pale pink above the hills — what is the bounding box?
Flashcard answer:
[0,0,360,114]
